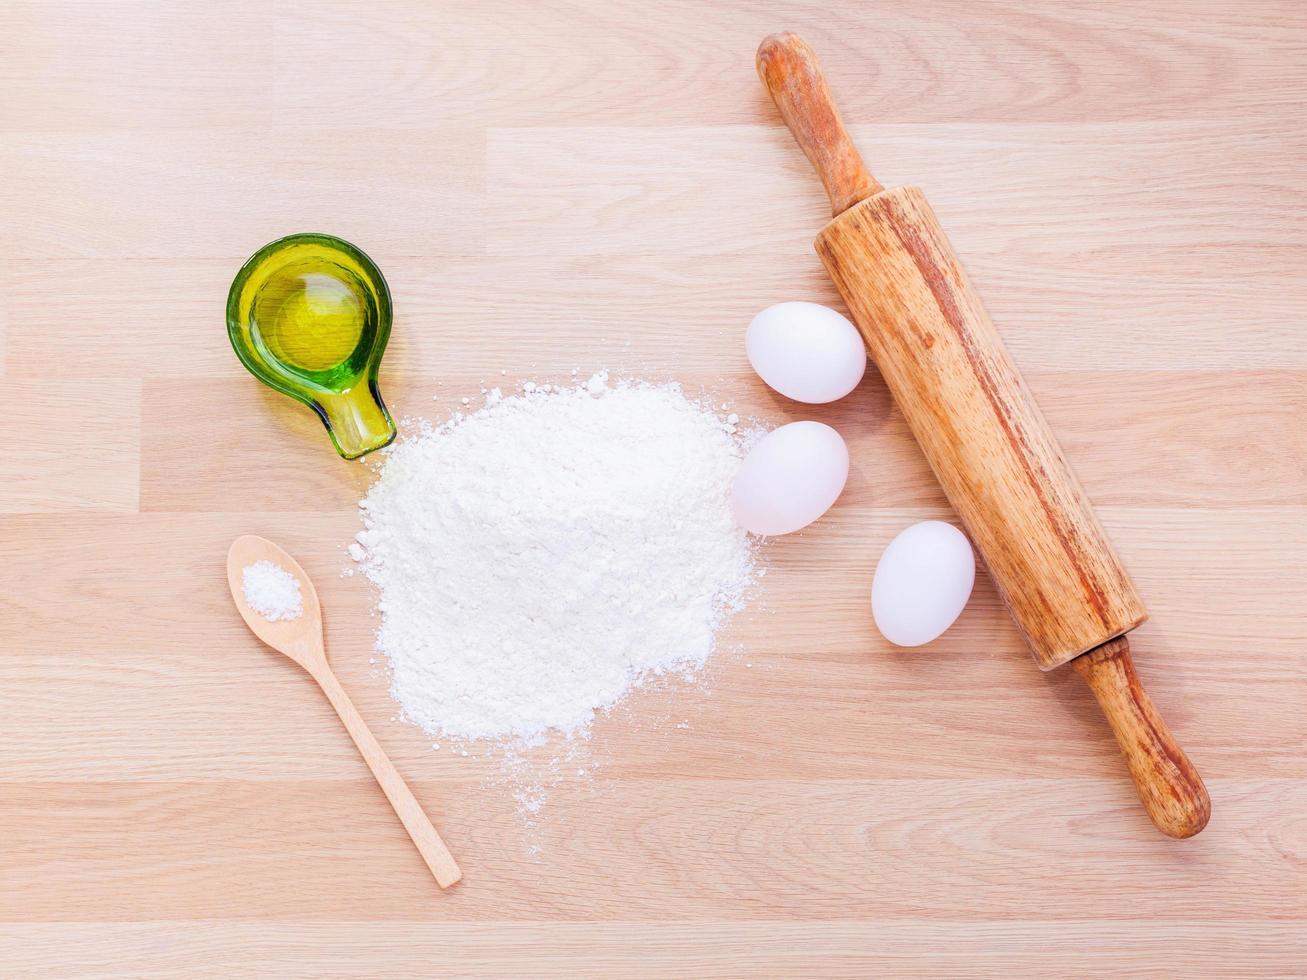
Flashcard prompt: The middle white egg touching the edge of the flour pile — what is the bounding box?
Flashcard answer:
[731,422,848,534]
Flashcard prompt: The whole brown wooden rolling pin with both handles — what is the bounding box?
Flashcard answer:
[758,34,1212,838]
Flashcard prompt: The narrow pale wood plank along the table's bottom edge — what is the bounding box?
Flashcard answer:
[0,920,1298,980]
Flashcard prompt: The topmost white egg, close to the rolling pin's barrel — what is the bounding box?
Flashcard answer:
[744,303,867,405]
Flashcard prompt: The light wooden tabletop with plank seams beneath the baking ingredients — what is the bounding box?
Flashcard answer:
[0,0,1307,977]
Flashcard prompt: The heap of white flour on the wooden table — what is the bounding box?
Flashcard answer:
[352,374,753,740]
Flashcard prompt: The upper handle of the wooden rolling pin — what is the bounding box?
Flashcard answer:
[758,33,885,216]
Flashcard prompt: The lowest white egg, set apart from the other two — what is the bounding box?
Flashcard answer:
[872,520,976,647]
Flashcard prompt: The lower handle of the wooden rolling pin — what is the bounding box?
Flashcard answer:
[1072,636,1212,838]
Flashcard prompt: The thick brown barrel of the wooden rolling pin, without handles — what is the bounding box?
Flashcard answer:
[817,187,1146,670]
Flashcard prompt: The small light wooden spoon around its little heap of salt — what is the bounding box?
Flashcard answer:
[227,534,463,889]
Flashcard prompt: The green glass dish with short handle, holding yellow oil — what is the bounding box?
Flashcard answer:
[227,234,395,460]
